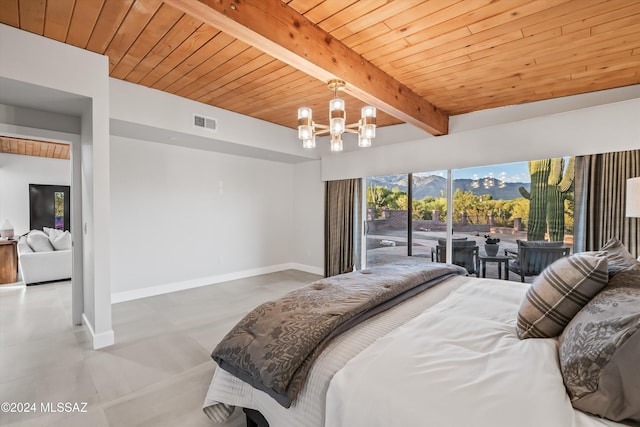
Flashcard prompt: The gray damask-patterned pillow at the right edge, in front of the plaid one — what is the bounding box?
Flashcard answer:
[559,266,640,423]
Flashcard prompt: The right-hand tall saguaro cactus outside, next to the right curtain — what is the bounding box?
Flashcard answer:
[547,157,576,242]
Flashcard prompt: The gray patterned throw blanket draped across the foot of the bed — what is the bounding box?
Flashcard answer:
[211,261,467,408]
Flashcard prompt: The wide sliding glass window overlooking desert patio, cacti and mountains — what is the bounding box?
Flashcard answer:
[366,158,574,265]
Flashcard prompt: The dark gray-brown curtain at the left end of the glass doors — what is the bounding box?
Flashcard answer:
[324,179,362,277]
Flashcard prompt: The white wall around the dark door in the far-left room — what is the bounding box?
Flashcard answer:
[0,153,71,235]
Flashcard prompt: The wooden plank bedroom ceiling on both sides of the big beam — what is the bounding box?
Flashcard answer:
[0,0,640,140]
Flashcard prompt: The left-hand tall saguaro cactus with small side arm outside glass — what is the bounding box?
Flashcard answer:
[518,159,551,241]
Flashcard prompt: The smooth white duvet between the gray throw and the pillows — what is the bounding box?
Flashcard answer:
[325,280,620,427]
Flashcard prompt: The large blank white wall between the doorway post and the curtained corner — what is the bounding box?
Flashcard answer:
[111,137,294,302]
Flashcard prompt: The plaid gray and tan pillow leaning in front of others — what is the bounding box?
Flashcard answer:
[517,253,608,339]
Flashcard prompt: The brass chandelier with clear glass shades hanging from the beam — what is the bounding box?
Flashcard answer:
[298,80,376,151]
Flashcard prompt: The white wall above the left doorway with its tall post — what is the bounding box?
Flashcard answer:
[0,24,114,348]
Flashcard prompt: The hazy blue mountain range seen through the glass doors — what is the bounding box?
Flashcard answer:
[367,174,531,200]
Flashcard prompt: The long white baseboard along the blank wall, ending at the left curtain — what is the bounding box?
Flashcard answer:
[111,263,324,304]
